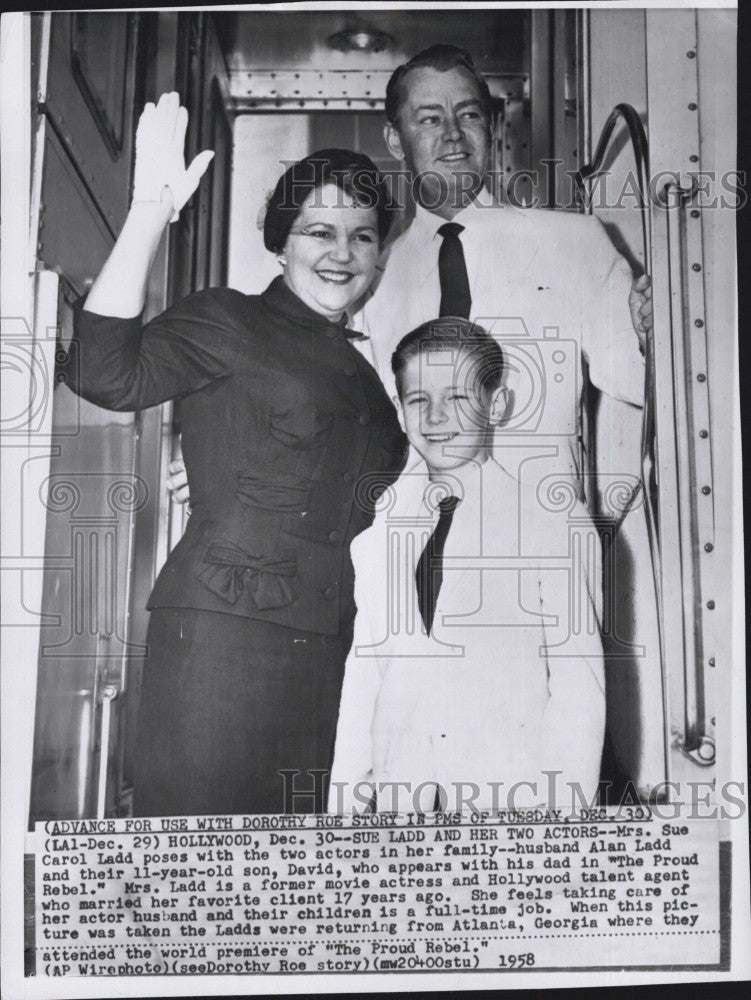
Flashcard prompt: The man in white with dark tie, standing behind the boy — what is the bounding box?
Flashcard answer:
[358,45,651,492]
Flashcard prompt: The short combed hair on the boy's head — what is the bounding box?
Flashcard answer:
[391,316,504,395]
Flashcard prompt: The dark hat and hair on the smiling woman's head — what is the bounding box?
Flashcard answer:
[263,149,396,253]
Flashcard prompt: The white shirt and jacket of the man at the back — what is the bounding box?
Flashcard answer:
[354,191,644,490]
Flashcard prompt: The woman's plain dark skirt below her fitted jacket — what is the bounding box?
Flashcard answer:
[133,608,352,816]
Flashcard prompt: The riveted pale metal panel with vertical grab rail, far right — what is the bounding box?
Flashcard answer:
[646,10,737,781]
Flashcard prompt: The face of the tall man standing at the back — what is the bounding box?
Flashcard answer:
[384,67,490,219]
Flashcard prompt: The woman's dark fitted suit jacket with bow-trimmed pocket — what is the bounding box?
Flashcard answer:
[68,278,406,634]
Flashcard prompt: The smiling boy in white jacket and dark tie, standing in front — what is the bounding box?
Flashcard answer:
[329,317,605,812]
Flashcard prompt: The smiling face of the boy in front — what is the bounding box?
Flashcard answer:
[397,347,506,472]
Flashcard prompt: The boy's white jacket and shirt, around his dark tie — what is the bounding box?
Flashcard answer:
[329,450,605,812]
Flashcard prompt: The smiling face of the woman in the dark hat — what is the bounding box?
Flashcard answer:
[284,184,379,322]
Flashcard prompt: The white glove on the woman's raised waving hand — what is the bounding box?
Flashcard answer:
[133,92,214,222]
